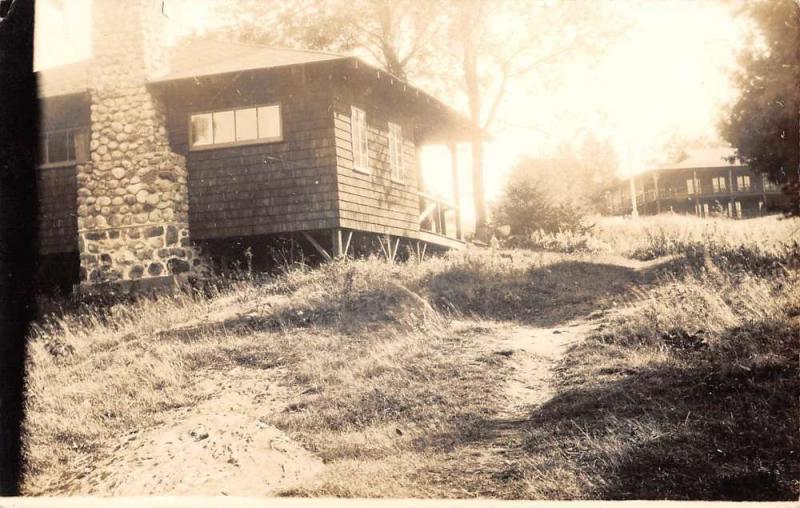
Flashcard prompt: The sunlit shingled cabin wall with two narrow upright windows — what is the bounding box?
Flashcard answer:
[333,86,420,238]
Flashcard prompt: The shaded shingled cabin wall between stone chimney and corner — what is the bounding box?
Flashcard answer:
[161,69,338,240]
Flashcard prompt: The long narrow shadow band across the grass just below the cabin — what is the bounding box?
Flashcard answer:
[156,261,676,339]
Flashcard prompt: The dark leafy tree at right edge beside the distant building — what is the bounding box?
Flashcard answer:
[720,0,800,213]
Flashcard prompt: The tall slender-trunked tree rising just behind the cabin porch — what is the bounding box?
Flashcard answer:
[448,0,620,237]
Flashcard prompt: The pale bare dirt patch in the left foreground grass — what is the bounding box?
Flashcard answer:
[56,368,324,496]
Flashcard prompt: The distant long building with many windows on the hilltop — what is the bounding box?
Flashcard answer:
[606,148,788,219]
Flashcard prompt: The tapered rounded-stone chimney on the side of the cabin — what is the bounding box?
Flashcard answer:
[77,0,200,285]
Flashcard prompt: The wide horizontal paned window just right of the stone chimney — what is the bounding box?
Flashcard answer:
[190,104,283,148]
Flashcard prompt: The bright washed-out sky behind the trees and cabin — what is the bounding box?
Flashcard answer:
[36,0,749,210]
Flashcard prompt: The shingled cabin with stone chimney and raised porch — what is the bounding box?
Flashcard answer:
[38,0,478,287]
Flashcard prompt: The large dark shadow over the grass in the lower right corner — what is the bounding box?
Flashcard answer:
[420,323,800,501]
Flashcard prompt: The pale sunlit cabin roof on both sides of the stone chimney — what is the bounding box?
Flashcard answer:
[38,39,348,97]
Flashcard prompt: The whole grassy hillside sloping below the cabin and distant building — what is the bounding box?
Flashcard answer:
[25,217,800,500]
